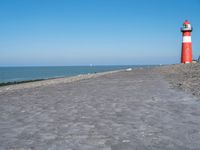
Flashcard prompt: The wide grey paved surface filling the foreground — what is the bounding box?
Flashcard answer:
[0,69,200,150]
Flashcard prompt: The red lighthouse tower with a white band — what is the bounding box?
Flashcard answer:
[181,20,192,64]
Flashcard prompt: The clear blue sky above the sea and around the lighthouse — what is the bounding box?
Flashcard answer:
[0,0,200,66]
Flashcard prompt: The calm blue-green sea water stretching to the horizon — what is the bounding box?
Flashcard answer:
[0,66,144,83]
